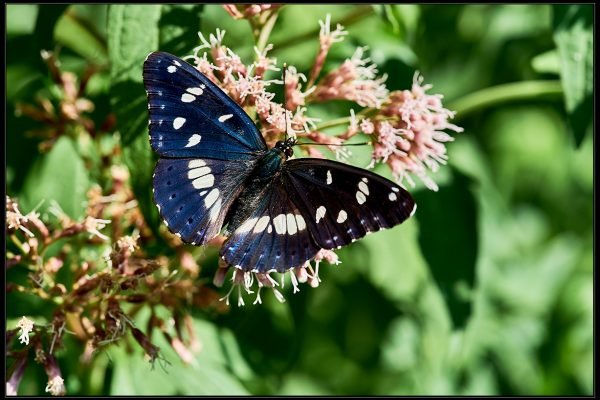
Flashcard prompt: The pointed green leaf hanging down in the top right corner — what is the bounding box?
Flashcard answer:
[552,4,594,146]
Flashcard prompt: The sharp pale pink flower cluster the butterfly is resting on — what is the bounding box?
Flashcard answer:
[186,5,462,304]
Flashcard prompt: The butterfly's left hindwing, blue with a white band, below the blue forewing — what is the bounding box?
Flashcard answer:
[153,158,255,245]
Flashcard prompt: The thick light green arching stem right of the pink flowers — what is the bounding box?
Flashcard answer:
[448,81,563,119]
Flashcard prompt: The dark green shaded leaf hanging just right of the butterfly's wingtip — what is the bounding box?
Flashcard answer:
[415,170,478,327]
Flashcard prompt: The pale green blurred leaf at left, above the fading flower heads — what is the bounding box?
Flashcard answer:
[21,136,90,219]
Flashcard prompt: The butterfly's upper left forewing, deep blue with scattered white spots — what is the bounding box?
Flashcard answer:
[144,52,267,160]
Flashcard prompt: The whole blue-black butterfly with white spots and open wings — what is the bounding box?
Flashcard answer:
[143,52,416,273]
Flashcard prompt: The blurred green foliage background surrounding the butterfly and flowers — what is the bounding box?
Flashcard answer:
[6,4,593,395]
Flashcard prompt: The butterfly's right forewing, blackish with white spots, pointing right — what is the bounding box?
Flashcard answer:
[283,158,415,249]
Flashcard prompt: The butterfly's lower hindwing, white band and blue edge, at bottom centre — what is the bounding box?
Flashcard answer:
[221,177,320,272]
